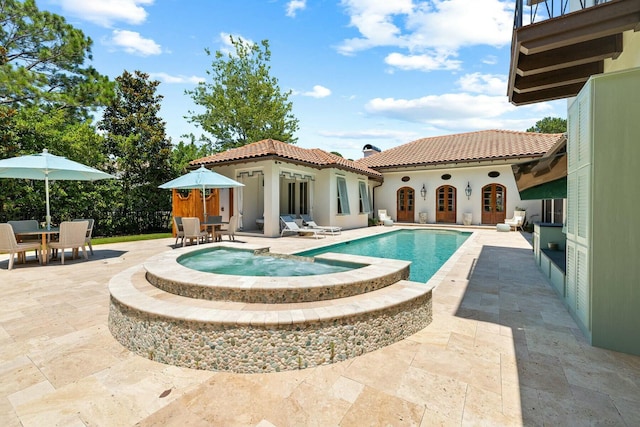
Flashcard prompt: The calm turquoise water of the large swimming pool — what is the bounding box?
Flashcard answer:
[296,230,471,283]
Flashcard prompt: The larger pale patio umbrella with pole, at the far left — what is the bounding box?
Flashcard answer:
[0,148,117,229]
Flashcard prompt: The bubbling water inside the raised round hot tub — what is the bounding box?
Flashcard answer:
[178,249,362,277]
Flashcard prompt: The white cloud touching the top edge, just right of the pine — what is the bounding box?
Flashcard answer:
[52,0,154,27]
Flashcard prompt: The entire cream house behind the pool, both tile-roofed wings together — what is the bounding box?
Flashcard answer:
[191,130,564,237]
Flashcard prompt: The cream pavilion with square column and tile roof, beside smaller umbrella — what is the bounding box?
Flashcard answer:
[191,139,383,237]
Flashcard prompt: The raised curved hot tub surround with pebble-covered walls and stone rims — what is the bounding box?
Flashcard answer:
[109,243,432,373]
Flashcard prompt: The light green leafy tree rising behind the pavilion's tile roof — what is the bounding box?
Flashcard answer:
[186,37,298,151]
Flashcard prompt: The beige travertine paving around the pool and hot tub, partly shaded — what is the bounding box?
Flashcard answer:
[0,226,640,427]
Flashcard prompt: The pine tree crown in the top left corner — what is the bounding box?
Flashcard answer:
[0,0,111,114]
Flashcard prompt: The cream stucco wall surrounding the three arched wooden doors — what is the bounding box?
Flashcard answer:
[374,163,541,224]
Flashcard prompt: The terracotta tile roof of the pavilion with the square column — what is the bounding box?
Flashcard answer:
[190,139,382,180]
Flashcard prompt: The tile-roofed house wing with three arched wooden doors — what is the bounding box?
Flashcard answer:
[356,130,564,225]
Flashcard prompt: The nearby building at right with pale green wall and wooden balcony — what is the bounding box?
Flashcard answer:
[508,0,640,355]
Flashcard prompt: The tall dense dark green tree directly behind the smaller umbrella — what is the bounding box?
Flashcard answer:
[98,71,172,216]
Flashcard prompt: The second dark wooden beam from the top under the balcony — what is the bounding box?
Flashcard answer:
[516,34,622,76]
